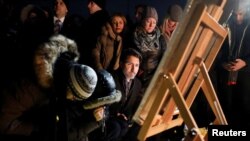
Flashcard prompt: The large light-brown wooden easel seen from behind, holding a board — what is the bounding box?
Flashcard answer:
[133,0,227,141]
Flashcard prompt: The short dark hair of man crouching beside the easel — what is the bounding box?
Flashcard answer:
[120,48,142,63]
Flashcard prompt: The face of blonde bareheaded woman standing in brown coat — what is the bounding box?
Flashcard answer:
[111,16,124,34]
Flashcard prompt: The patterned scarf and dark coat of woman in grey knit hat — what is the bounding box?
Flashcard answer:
[134,26,167,81]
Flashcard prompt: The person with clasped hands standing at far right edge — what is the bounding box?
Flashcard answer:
[217,0,250,127]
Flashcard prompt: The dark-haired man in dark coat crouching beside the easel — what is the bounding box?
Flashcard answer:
[93,48,142,141]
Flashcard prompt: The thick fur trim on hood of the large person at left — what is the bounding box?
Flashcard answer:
[33,34,80,88]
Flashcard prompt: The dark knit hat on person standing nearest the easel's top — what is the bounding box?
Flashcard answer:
[168,4,183,22]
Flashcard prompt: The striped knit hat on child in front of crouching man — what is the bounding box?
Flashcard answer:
[69,64,97,100]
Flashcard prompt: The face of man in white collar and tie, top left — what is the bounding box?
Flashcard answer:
[54,0,68,18]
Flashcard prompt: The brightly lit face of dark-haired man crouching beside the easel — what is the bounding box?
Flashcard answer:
[121,56,140,81]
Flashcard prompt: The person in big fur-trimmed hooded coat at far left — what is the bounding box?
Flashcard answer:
[0,35,79,141]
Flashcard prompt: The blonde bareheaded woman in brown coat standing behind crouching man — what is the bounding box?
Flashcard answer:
[92,13,127,71]
